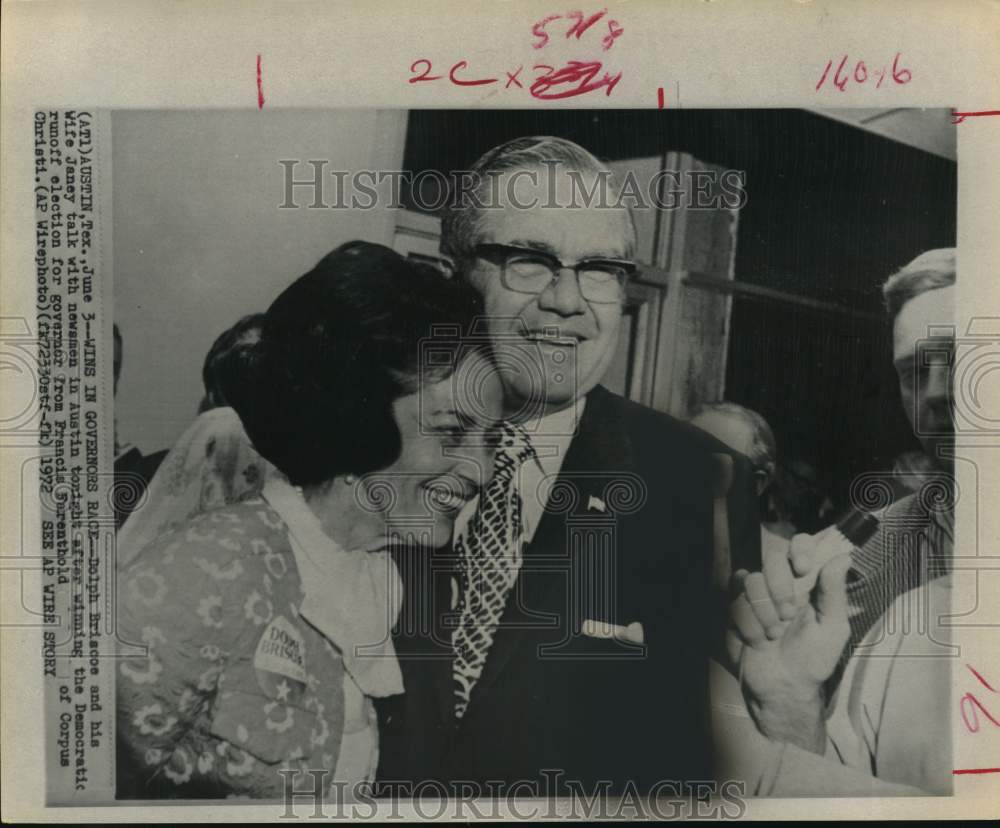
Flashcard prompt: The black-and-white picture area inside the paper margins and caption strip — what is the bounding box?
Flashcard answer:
[101,105,956,799]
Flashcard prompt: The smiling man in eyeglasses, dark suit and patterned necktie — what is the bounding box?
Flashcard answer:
[379,137,756,796]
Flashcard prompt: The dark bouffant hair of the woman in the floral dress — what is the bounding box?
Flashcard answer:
[229,242,481,486]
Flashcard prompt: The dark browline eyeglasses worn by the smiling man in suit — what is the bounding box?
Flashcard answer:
[472,244,636,304]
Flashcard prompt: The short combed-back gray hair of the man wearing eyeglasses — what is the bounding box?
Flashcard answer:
[441,135,635,264]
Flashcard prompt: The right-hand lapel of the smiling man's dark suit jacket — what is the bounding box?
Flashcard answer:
[466,386,635,704]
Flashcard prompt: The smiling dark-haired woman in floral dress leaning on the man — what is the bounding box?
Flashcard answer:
[118,242,501,798]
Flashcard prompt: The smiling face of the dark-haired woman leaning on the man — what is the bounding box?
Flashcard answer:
[360,353,503,547]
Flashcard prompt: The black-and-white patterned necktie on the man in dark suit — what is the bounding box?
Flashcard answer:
[452,423,536,719]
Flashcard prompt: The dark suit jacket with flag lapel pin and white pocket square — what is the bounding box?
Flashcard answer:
[379,387,759,795]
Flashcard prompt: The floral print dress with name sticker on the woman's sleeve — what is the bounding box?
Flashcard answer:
[117,497,378,799]
